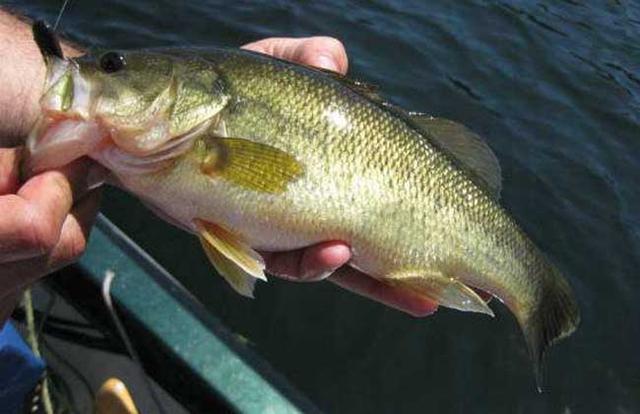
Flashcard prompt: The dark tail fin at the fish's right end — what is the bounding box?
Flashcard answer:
[520,269,580,392]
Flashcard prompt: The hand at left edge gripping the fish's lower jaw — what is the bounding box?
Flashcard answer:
[0,148,106,326]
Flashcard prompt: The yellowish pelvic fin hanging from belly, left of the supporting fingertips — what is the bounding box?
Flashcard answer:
[195,219,267,298]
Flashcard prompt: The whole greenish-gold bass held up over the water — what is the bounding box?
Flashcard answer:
[23,23,580,386]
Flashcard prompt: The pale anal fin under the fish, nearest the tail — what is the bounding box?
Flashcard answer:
[386,271,494,316]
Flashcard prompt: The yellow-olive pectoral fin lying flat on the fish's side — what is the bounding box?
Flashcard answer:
[200,137,303,194]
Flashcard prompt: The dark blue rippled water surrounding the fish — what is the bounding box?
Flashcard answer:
[11,0,640,413]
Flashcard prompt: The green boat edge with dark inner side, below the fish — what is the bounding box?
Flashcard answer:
[51,215,320,413]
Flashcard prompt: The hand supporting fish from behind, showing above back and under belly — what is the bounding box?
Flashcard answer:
[243,37,438,316]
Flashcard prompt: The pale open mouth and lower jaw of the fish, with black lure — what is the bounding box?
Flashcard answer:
[21,22,211,179]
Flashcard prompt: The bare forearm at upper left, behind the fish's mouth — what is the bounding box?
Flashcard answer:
[0,9,79,147]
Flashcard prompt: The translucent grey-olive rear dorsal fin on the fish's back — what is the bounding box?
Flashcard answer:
[408,113,502,198]
